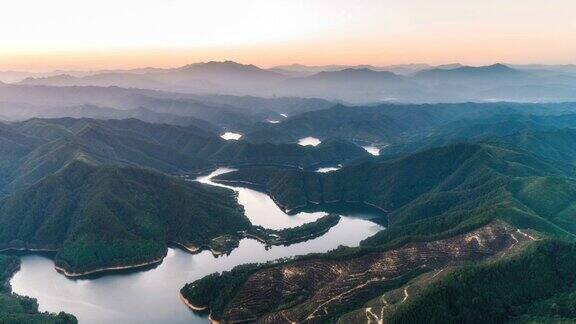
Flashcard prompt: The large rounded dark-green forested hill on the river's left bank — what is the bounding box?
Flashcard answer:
[0,160,251,274]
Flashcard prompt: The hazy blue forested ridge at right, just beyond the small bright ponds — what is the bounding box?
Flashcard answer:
[244,102,576,146]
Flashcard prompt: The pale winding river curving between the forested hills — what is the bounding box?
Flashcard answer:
[10,168,382,324]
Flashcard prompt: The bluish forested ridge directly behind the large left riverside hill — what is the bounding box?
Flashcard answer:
[0,118,367,194]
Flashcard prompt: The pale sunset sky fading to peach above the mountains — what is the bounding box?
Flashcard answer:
[0,0,576,71]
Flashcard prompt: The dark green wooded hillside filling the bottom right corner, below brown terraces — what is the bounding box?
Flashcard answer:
[384,241,576,323]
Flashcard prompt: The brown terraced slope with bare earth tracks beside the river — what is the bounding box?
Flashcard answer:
[182,222,534,323]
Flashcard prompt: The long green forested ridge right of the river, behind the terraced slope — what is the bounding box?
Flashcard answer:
[217,144,576,240]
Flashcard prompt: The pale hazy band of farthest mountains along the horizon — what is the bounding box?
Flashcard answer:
[0,61,576,103]
